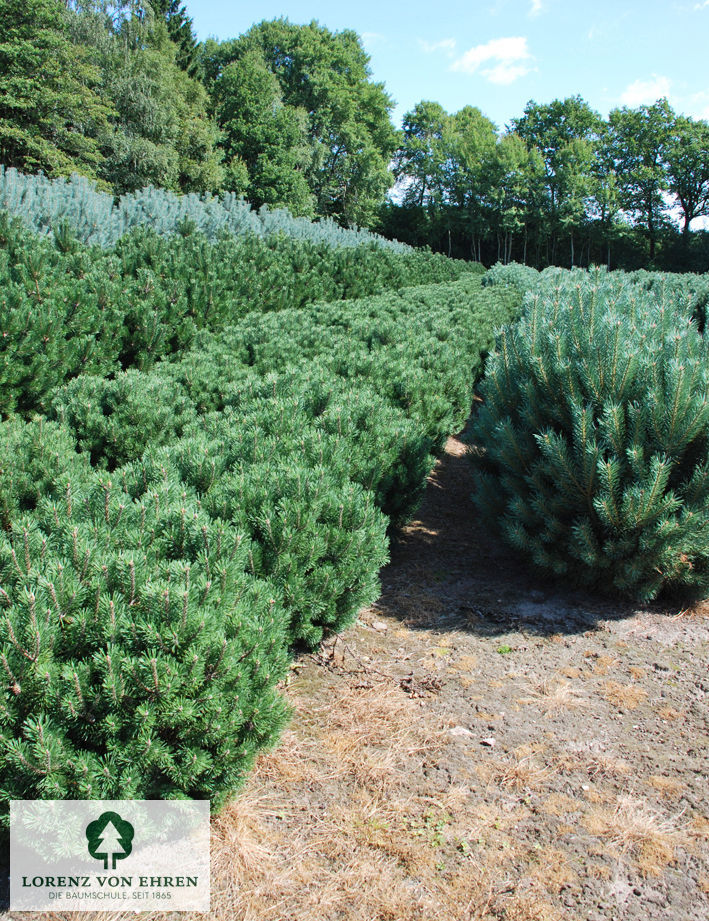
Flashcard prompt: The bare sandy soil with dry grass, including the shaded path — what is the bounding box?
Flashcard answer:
[6,438,709,921]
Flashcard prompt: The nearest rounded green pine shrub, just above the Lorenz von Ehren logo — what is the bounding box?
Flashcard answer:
[0,459,287,818]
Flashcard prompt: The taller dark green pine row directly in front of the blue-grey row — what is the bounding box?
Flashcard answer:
[0,215,478,415]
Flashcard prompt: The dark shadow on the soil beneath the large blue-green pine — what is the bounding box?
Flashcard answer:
[377,428,680,636]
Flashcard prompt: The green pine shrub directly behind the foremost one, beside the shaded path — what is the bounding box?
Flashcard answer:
[167,424,388,648]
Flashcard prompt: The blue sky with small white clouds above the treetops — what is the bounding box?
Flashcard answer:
[186,0,709,128]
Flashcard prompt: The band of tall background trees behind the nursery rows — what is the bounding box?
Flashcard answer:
[0,0,709,271]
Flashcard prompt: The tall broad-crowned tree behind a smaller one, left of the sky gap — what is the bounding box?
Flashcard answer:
[204,19,397,225]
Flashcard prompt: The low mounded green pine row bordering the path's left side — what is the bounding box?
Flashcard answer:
[0,275,520,807]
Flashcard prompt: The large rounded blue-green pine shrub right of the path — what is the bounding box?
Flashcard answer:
[471,273,709,599]
